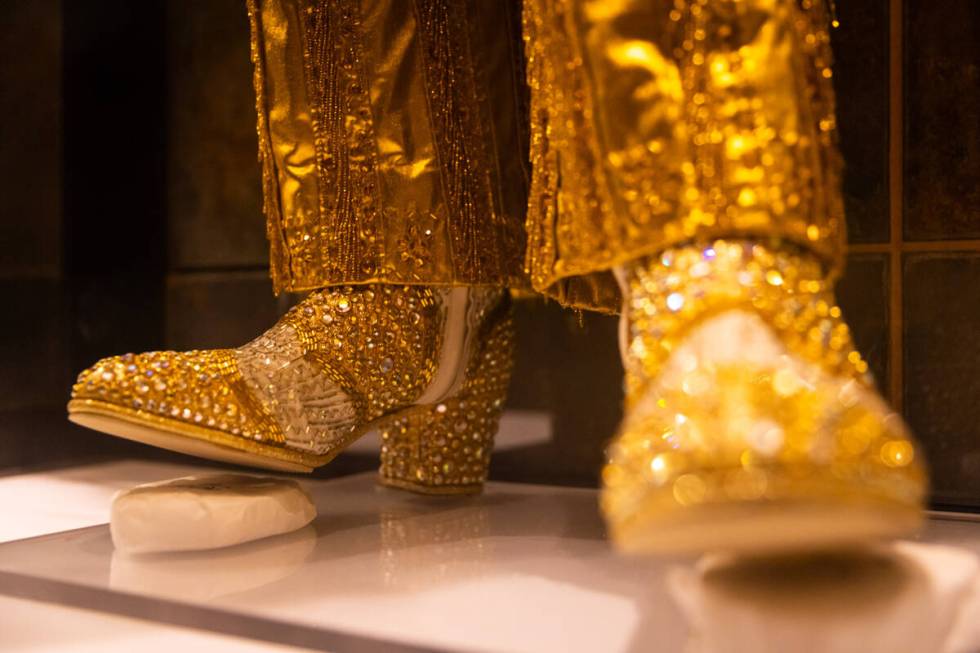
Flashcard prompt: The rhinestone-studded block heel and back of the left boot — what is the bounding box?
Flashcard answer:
[379,301,514,494]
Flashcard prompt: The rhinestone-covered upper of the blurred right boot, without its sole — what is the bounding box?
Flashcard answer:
[602,240,925,538]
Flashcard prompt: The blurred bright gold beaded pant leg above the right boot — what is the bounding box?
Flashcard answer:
[523,0,844,310]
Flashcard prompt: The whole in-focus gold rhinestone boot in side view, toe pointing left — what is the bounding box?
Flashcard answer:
[68,284,513,493]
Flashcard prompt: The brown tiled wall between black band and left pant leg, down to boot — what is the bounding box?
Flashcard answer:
[166,0,282,356]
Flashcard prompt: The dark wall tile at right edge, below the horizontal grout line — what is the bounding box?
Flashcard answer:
[903,253,980,509]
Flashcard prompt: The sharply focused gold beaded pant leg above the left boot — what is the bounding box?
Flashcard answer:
[248,0,530,291]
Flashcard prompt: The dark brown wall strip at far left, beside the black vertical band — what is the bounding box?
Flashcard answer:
[0,0,66,418]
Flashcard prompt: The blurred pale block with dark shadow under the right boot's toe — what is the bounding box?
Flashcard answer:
[667,542,980,653]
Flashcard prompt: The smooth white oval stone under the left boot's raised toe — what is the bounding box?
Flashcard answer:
[109,474,316,553]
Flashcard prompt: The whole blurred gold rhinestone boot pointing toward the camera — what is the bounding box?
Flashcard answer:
[602,241,926,554]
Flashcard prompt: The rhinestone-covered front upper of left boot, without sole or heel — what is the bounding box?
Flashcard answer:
[70,284,445,456]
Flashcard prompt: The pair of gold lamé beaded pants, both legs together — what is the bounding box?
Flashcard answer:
[248,0,844,311]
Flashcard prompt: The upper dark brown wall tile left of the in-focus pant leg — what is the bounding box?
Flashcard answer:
[166,0,267,269]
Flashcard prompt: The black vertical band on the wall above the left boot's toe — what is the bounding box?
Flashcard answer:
[61,0,168,368]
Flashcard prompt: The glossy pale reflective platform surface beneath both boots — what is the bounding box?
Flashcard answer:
[0,464,980,652]
